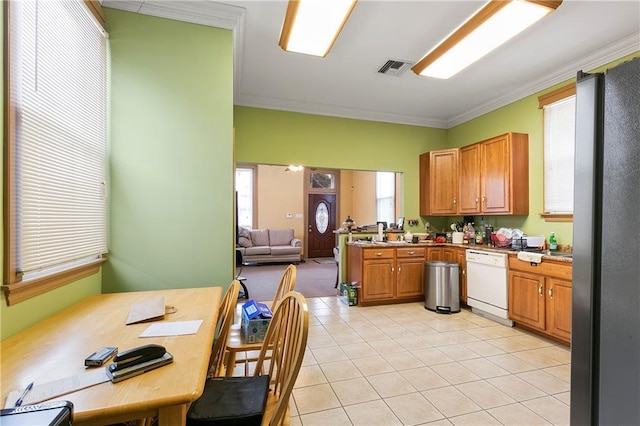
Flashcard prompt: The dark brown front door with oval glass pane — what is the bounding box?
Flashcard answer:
[307,194,336,258]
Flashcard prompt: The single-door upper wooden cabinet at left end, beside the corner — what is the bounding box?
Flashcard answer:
[420,149,458,216]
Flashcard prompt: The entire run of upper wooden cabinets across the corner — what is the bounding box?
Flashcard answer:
[420,133,529,216]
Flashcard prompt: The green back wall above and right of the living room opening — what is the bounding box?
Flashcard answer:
[234,106,447,230]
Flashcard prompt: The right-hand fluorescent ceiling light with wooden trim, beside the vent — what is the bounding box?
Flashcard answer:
[411,0,562,79]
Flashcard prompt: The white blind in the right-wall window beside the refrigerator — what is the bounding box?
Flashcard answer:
[544,95,576,213]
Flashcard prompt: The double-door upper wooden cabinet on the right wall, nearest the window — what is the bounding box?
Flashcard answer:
[458,133,529,214]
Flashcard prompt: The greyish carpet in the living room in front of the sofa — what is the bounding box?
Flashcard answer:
[241,262,338,302]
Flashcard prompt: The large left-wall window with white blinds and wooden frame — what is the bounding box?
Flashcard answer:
[3,0,107,304]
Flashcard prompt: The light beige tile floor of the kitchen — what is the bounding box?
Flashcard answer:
[291,297,570,426]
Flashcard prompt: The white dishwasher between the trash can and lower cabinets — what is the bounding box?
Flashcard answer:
[467,249,513,327]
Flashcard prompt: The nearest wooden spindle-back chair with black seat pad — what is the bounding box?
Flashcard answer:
[187,291,309,426]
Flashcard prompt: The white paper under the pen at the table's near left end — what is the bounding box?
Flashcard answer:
[4,368,109,408]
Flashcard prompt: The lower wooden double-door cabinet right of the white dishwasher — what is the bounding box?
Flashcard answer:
[509,257,572,343]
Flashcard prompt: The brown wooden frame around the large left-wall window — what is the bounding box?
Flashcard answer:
[1,0,107,306]
